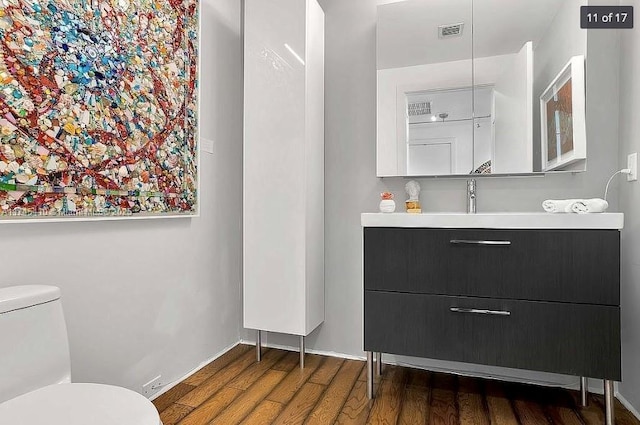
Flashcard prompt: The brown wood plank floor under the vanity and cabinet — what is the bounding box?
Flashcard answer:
[154,345,640,425]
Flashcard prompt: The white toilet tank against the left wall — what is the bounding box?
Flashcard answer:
[0,285,71,403]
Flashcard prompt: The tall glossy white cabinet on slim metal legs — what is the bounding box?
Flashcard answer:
[243,0,324,366]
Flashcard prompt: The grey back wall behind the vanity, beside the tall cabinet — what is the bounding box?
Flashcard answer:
[244,0,618,392]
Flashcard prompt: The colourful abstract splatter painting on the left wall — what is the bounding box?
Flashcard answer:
[0,0,198,220]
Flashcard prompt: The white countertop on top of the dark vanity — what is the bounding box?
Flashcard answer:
[360,212,624,229]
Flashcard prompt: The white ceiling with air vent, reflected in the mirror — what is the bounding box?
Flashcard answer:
[377,0,564,69]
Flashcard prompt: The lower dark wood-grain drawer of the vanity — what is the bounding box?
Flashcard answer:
[364,291,621,380]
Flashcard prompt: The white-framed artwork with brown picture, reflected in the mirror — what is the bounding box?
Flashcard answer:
[540,56,587,171]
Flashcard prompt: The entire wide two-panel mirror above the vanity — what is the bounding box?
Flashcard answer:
[377,0,587,177]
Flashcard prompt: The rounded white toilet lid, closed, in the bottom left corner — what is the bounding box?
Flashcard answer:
[0,384,161,425]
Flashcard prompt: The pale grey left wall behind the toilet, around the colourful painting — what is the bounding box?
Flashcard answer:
[0,0,242,398]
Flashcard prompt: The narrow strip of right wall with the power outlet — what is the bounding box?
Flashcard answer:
[617,20,640,412]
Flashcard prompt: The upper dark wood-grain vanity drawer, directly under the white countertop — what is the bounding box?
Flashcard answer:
[364,227,620,306]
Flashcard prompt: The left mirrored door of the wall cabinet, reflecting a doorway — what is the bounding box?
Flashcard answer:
[377,0,474,176]
